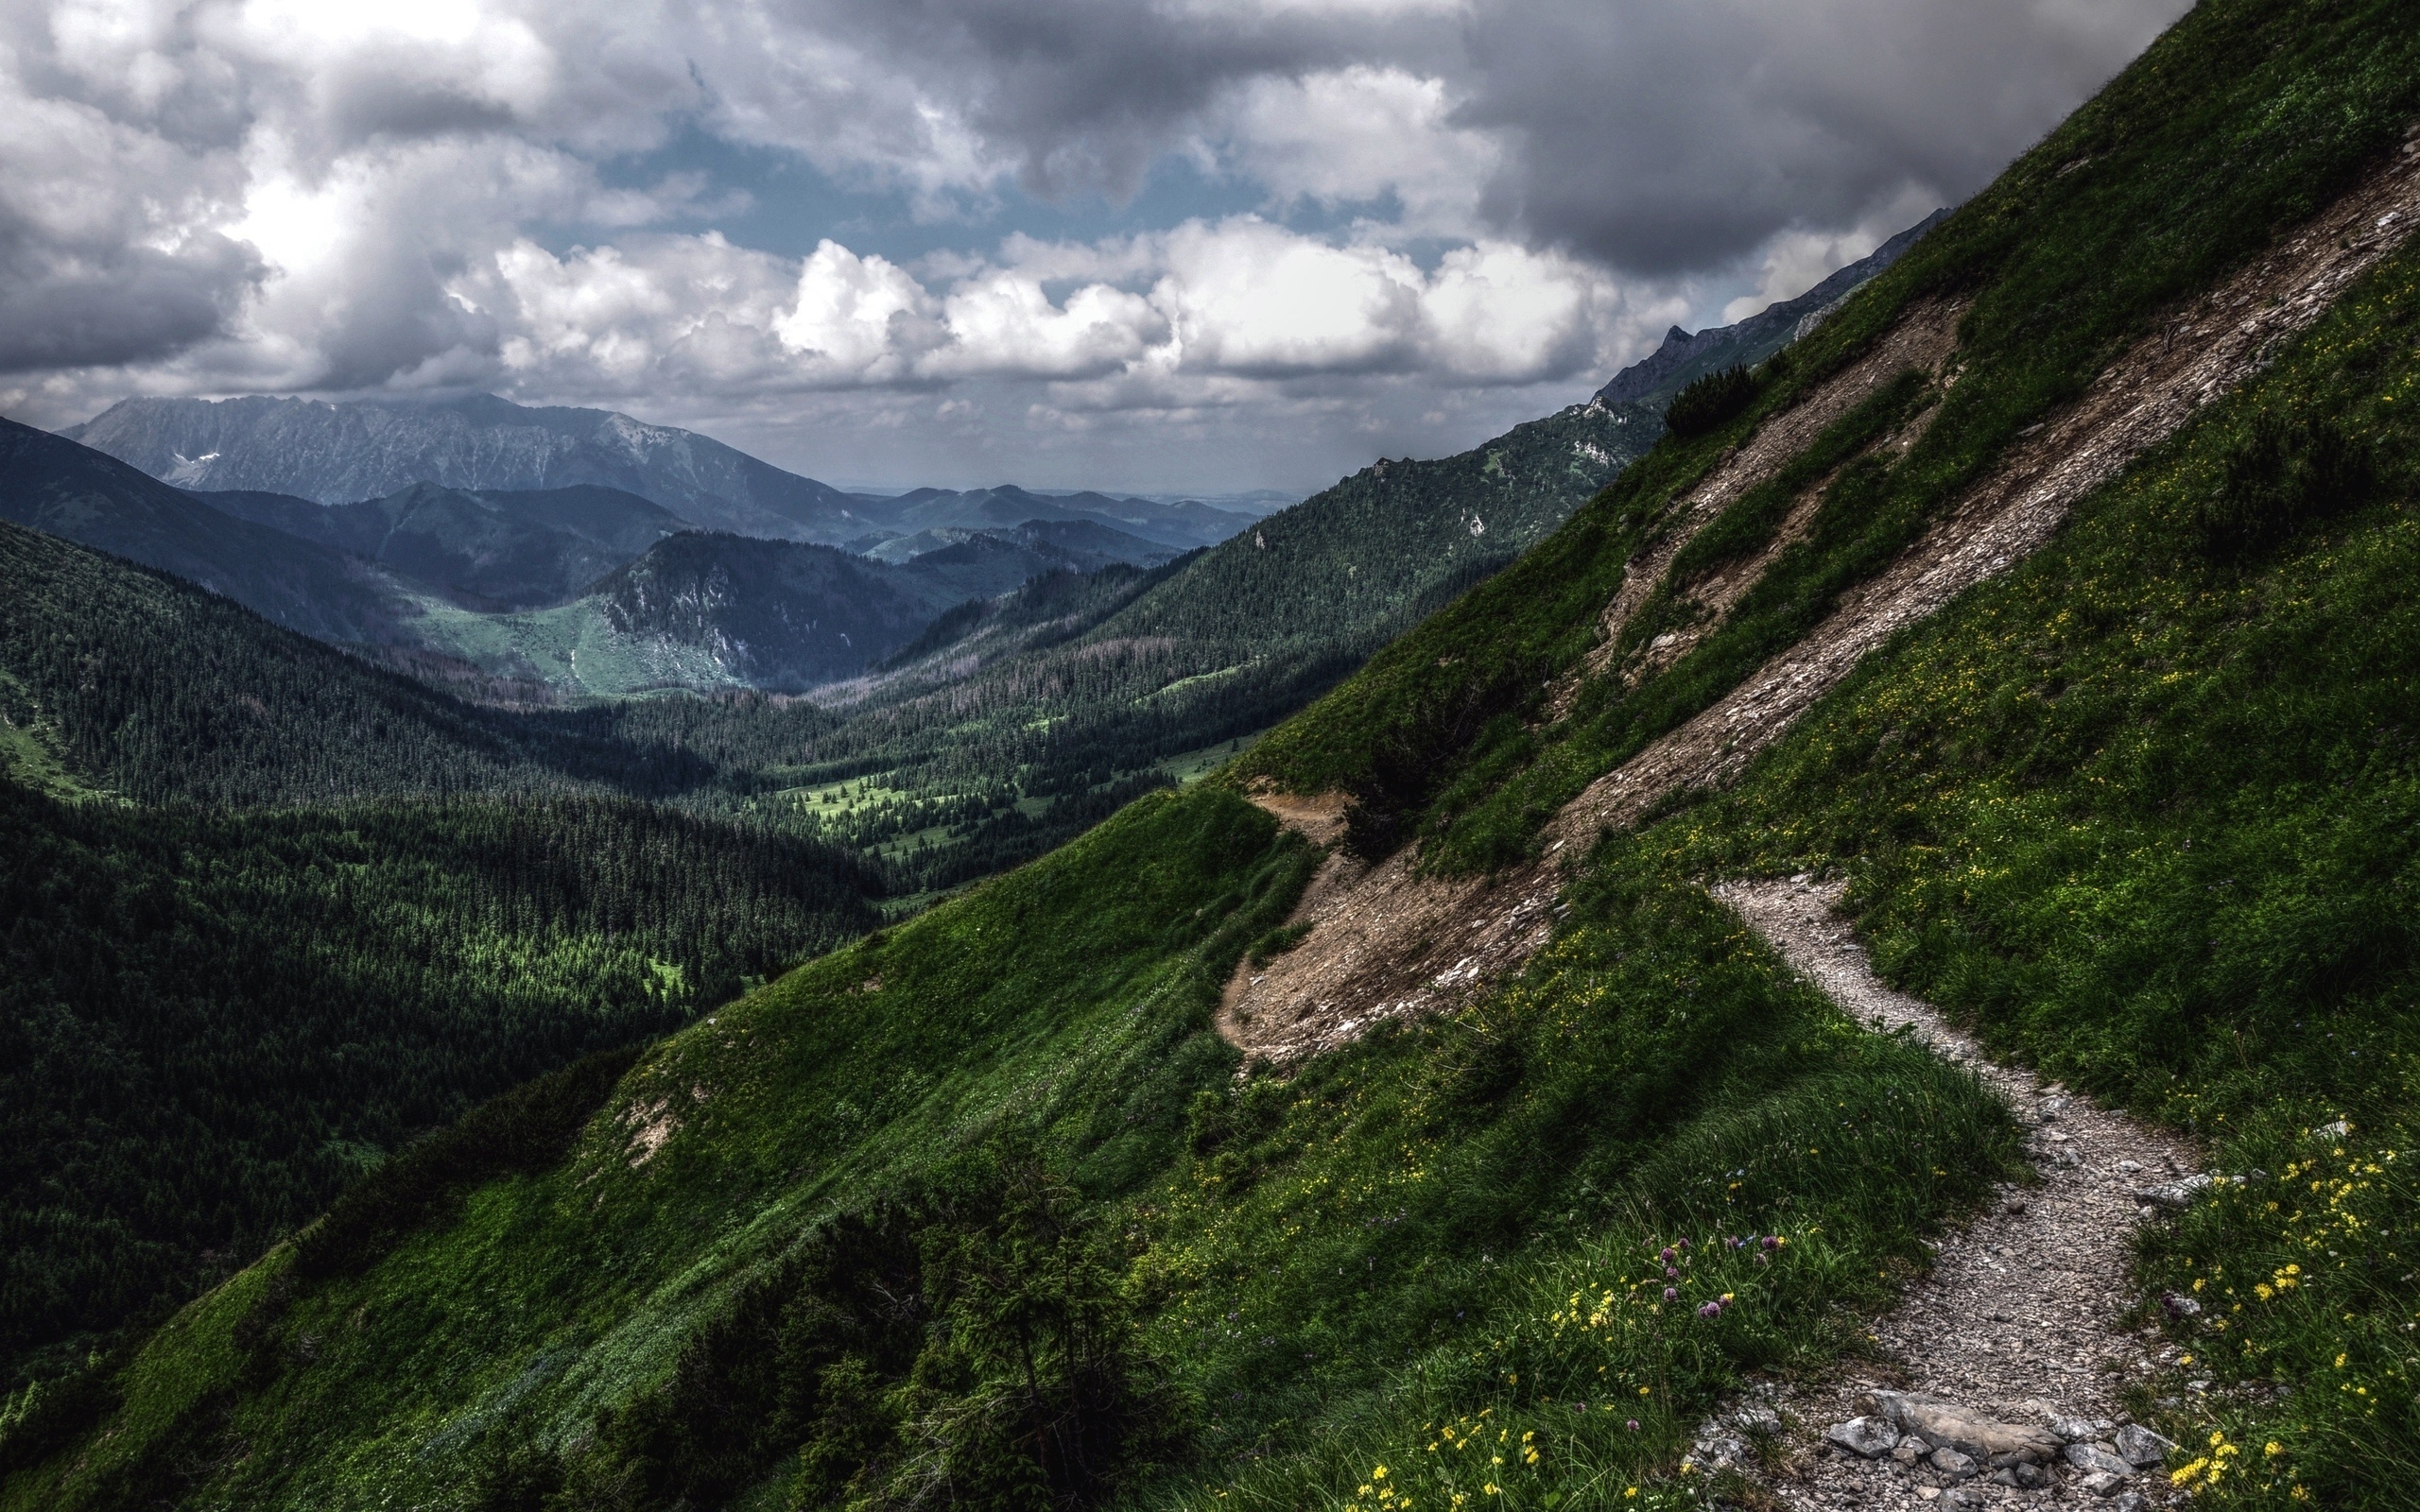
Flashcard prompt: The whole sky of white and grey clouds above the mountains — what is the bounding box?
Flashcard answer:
[0,0,2186,491]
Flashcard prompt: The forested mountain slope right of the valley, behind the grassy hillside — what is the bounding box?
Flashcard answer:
[752,404,1663,885]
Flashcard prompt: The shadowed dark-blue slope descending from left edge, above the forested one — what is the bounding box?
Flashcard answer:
[0,419,411,641]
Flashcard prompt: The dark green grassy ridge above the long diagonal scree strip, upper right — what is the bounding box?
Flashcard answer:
[1239,0,2420,868]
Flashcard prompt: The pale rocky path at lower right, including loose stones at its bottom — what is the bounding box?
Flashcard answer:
[1697,878,2207,1512]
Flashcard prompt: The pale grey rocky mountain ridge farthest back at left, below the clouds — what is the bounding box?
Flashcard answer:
[60,394,866,541]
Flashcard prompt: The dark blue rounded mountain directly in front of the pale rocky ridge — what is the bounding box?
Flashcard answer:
[194,484,695,610]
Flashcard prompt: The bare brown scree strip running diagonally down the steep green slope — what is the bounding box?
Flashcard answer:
[1219,138,2420,1059]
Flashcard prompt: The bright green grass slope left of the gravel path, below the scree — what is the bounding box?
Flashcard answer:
[0,789,2014,1507]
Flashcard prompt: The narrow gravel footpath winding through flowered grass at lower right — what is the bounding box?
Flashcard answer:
[1699,881,2200,1507]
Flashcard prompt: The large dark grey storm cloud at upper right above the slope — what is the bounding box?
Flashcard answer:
[1461,0,2186,273]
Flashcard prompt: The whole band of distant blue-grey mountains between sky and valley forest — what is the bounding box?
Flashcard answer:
[0,220,1933,718]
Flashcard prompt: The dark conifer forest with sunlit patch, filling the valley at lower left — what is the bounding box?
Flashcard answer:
[0,782,876,1382]
